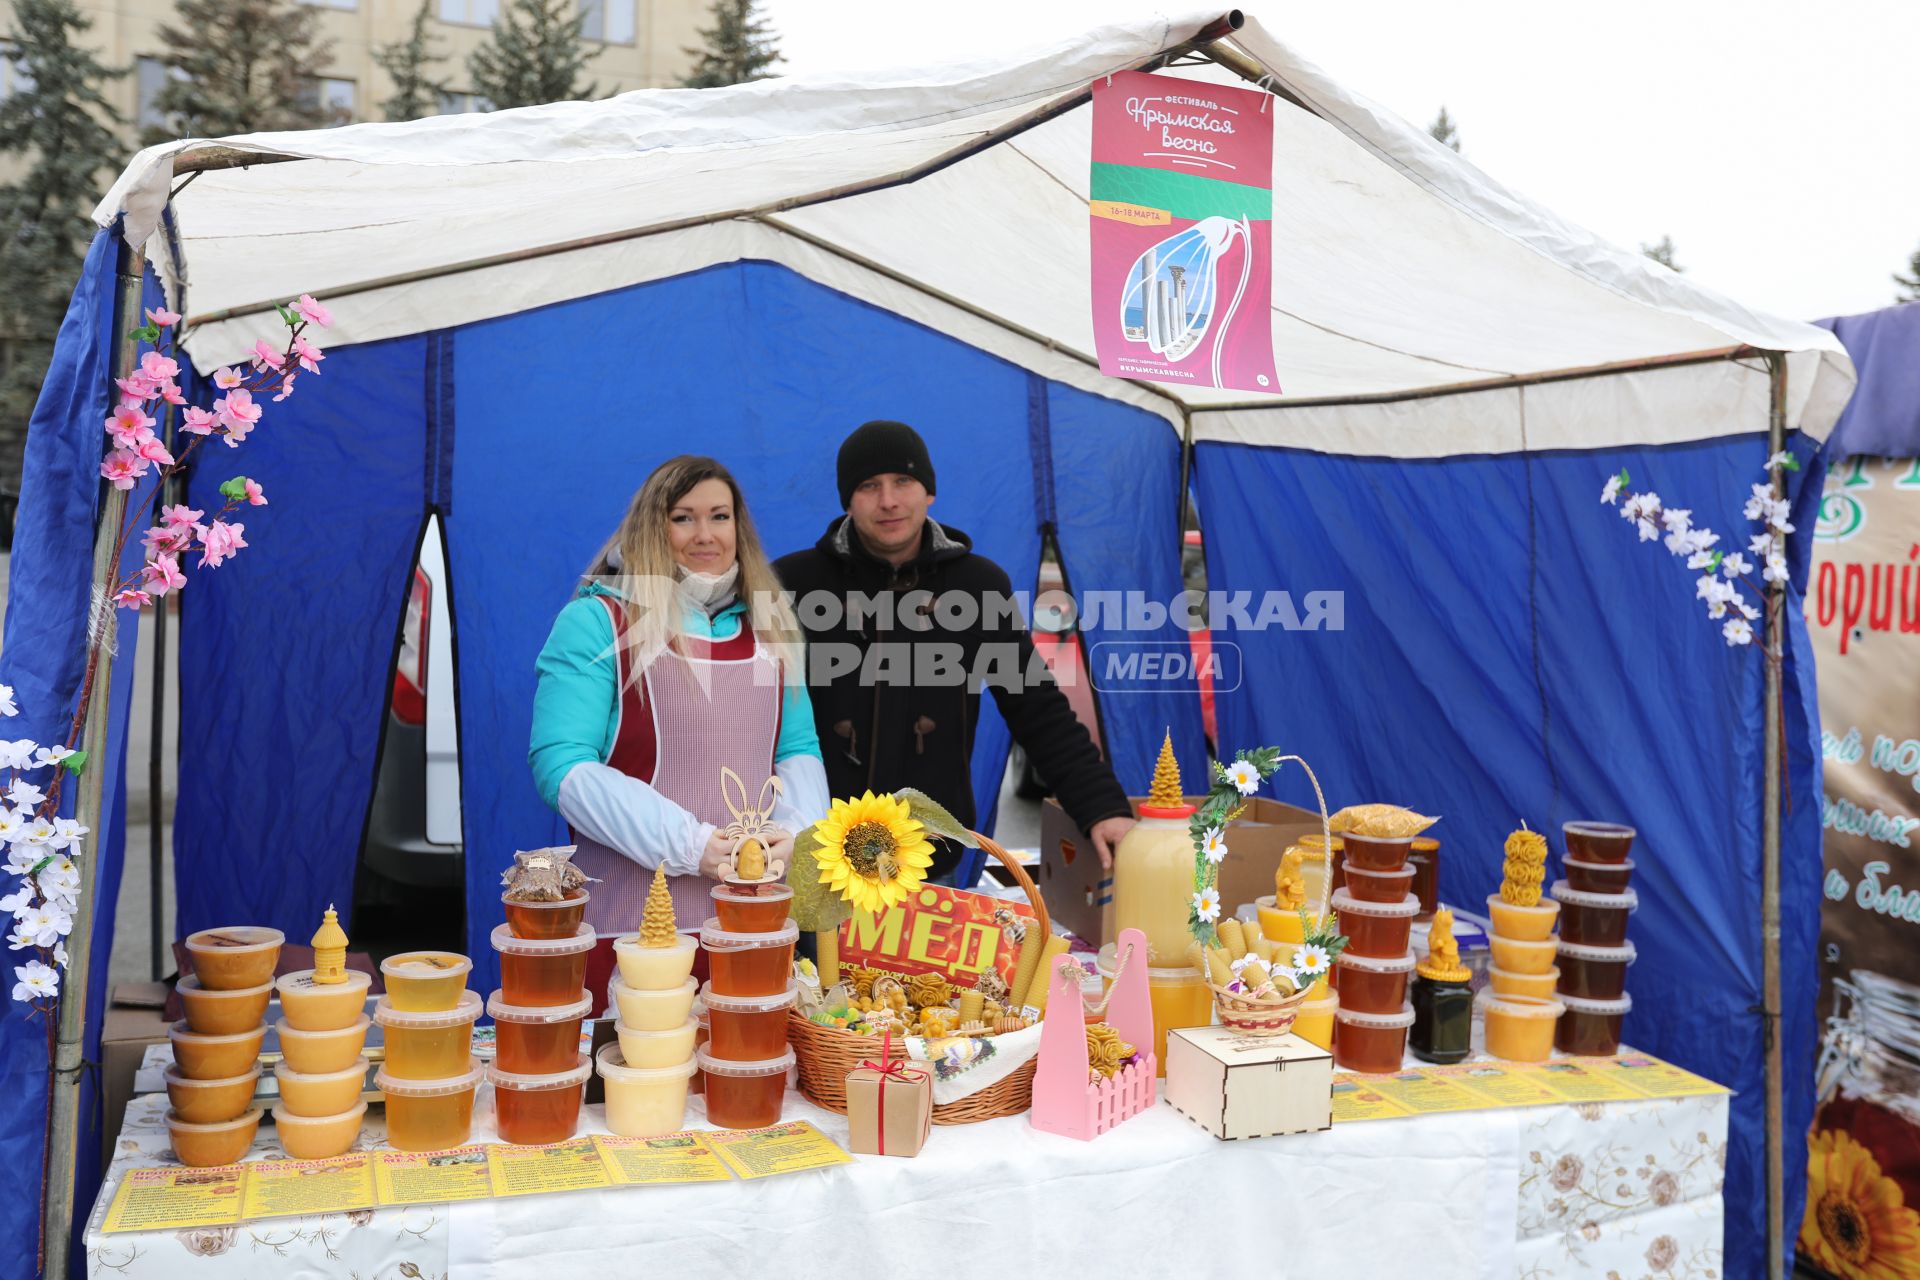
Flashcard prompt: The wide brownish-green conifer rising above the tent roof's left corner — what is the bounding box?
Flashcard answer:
[144,0,340,144]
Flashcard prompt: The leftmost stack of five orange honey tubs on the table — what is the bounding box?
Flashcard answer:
[167,925,286,1165]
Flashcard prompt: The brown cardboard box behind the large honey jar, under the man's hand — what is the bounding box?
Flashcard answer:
[1035,796,1321,946]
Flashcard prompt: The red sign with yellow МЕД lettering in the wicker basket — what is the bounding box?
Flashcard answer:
[841,885,1033,986]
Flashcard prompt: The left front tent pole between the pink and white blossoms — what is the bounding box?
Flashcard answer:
[40,238,140,1280]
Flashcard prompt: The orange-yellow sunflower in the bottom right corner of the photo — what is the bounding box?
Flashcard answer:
[1799,1128,1920,1280]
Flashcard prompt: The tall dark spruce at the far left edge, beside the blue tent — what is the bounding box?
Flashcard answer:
[0,0,125,489]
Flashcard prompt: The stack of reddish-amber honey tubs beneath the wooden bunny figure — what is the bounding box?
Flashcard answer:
[697,867,801,1128]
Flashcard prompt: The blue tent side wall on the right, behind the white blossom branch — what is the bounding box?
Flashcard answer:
[1196,426,1820,1276]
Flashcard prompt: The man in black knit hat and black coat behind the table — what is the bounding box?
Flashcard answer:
[774,422,1133,873]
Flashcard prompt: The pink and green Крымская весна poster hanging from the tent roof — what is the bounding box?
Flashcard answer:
[1089,71,1281,395]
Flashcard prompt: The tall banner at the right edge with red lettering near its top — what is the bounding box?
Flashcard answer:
[1795,459,1920,1280]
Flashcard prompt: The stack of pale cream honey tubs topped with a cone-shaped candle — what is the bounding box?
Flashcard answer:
[599,871,699,1138]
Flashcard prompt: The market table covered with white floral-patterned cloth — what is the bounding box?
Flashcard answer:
[86,1090,1728,1280]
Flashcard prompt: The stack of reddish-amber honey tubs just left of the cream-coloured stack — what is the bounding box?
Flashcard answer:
[480,889,595,1146]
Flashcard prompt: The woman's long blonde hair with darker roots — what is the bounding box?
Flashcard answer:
[582,453,804,683]
